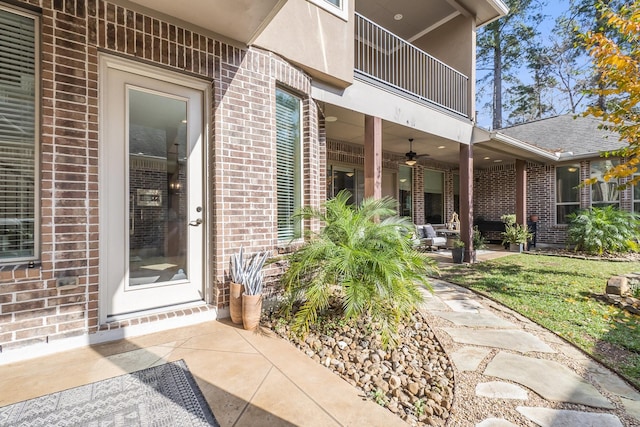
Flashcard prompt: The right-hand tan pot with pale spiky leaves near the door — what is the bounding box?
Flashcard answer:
[242,251,269,330]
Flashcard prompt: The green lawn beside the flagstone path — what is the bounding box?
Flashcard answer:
[442,254,640,388]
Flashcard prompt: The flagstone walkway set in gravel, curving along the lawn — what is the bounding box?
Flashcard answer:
[423,280,640,427]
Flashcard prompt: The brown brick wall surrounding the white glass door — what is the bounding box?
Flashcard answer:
[0,0,326,351]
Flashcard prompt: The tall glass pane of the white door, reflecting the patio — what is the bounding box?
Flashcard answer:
[128,92,188,286]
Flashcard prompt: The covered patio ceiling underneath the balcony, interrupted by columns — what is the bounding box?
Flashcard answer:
[324,104,554,169]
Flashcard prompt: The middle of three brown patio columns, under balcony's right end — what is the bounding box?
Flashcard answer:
[458,144,473,262]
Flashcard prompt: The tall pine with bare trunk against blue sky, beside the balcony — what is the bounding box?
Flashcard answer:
[477,0,543,129]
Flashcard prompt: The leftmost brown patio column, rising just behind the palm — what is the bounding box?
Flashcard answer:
[364,116,382,199]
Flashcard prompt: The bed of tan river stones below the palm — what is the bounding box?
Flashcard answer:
[261,313,454,426]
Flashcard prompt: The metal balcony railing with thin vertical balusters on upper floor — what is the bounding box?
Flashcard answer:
[355,13,469,118]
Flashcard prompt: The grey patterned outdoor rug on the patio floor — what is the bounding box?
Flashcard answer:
[0,360,219,427]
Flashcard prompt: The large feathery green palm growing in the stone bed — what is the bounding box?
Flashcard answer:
[282,191,437,352]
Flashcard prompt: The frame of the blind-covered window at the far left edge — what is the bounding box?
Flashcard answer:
[0,3,42,266]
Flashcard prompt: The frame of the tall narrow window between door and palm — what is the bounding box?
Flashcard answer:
[275,85,304,244]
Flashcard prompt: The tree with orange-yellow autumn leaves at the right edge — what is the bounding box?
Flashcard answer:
[582,0,640,185]
